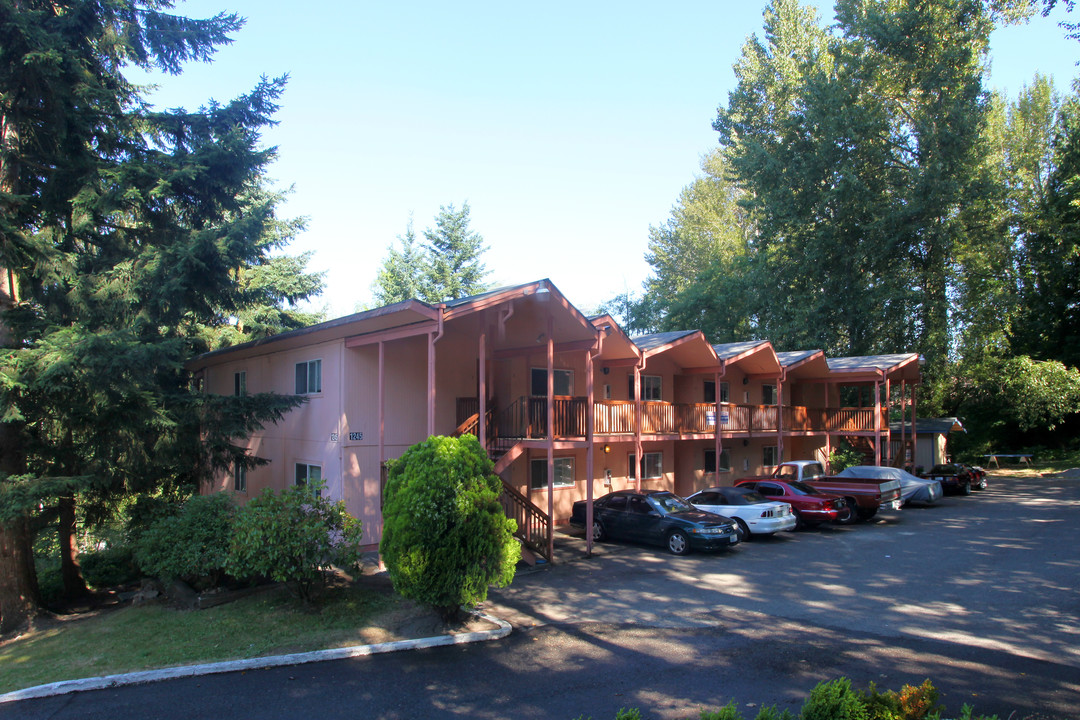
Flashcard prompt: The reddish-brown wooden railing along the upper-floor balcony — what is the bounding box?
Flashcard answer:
[458,396,888,443]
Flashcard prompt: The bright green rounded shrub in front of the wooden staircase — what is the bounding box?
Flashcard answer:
[379,435,522,620]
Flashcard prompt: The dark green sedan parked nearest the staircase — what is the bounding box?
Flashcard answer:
[570,490,741,555]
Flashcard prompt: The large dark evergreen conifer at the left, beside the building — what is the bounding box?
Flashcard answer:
[0,0,304,630]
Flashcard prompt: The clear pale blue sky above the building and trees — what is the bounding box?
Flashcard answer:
[139,0,1080,317]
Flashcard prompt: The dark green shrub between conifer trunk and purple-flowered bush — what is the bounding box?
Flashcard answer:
[135,492,237,585]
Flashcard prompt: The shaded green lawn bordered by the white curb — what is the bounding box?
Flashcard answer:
[0,586,405,694]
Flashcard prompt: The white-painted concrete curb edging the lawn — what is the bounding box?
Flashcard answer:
[0,613,513,704]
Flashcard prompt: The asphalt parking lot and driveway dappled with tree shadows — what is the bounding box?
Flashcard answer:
[10,478,1080,720]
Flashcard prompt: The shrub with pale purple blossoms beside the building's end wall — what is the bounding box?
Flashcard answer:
[227,485,362,602]
